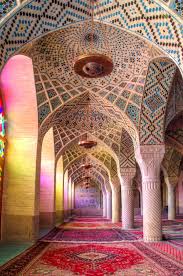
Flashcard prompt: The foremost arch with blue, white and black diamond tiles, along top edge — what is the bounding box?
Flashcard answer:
[0,0,183,73]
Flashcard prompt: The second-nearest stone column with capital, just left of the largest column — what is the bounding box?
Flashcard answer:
[121,168,135,229]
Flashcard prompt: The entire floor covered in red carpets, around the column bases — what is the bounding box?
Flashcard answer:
[0,216,183,276]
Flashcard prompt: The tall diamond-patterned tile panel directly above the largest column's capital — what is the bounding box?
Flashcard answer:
[140,59,176,144]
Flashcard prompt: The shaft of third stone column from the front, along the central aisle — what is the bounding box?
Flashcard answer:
[112,185,120,223]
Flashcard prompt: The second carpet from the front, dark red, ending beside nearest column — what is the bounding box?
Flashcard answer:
[41,228,142,243]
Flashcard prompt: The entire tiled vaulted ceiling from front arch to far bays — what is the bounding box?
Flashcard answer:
[0,0,183,187]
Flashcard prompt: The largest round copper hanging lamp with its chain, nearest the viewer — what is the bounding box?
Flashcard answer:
[74,0,113,78]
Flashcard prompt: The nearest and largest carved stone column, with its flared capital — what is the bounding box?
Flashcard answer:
[135,145,165,242]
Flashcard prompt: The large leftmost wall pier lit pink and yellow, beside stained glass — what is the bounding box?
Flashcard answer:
[0,55,39,241]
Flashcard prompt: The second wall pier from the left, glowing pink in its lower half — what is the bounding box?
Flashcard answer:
[40,128,56,227]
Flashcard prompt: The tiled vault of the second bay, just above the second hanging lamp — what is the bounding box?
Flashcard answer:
[53,93,124,156]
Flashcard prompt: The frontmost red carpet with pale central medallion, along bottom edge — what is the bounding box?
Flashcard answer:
[0,242,183,276]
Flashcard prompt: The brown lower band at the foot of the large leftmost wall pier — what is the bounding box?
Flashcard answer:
[2,215,39,241]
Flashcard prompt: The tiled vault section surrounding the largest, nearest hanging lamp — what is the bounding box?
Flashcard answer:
[22,23,156,135]
